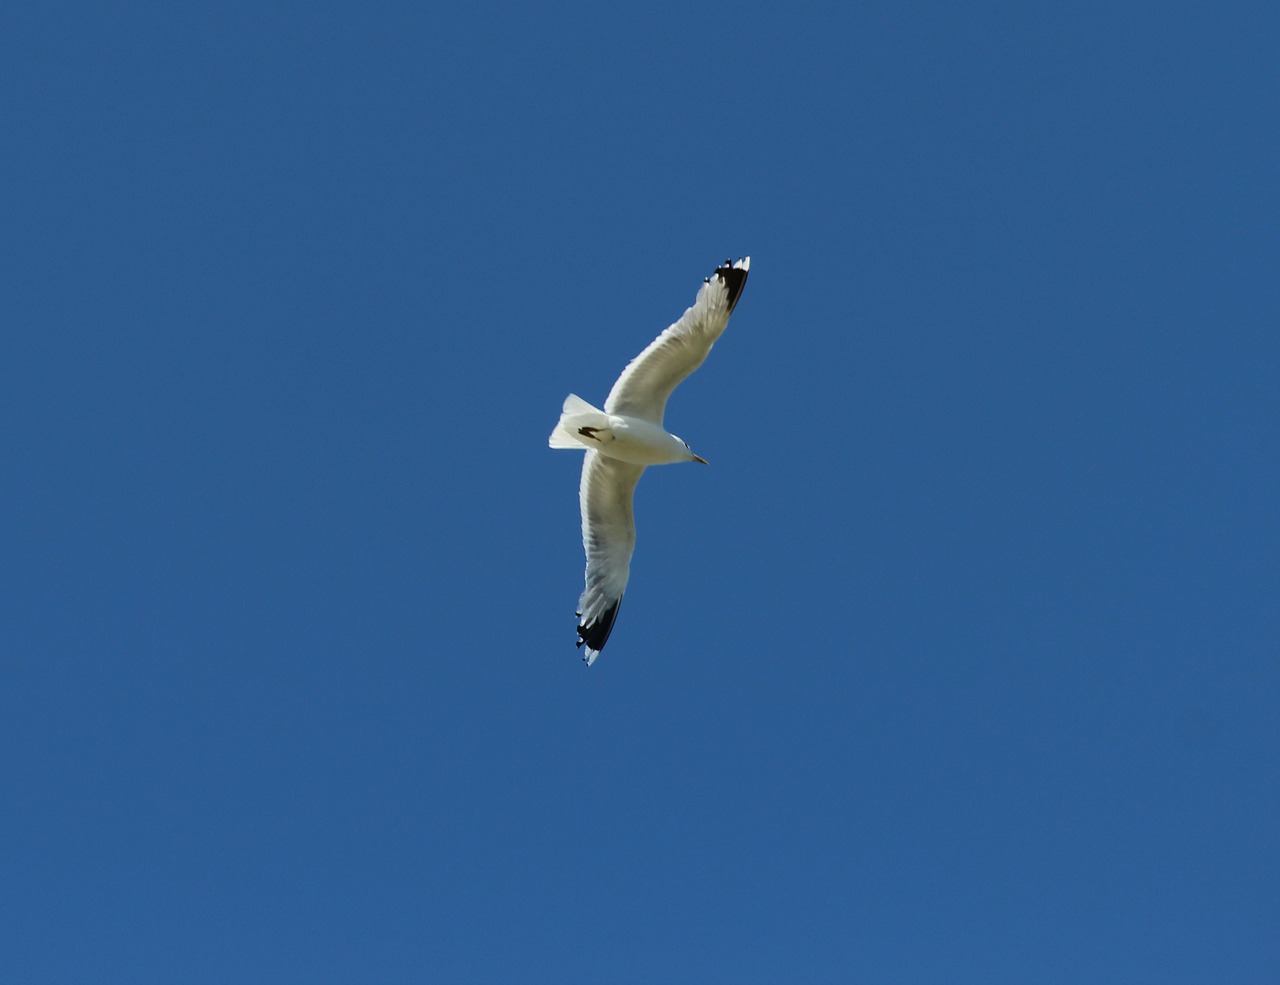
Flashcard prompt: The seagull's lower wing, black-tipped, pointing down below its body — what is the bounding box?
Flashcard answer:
[577,450,644,665]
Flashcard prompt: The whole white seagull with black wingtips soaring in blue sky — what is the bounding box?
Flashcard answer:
[548,257,751,666]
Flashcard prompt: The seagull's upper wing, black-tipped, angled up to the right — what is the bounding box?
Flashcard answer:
[604,257,751,425]
